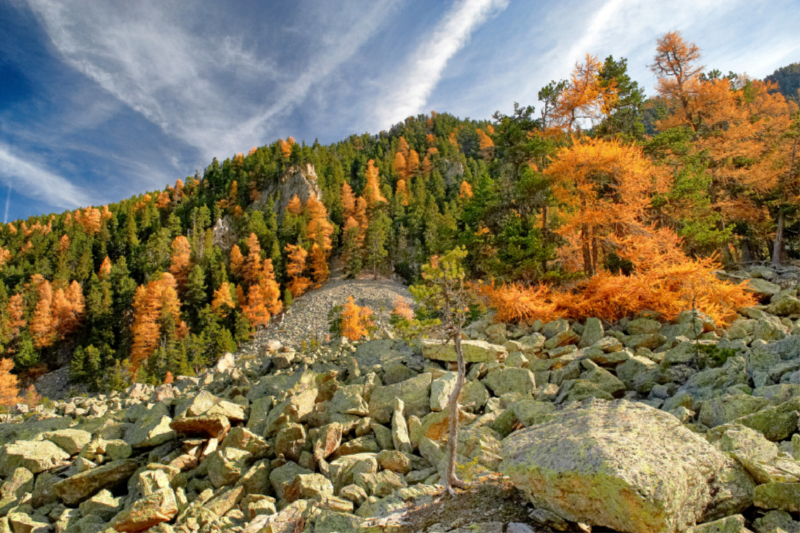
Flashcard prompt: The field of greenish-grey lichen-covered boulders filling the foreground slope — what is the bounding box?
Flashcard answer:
[0,272,800,533]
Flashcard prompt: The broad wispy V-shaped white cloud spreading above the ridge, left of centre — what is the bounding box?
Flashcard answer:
[28,0,395,162]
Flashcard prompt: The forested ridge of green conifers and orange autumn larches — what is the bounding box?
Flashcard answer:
[0,33,800,390]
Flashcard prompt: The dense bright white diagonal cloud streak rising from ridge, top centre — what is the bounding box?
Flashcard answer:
[375,0,508,127]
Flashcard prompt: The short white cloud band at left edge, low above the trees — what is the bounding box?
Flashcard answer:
[0,144,93,209]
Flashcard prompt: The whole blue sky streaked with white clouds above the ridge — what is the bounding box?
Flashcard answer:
[0,0,800,221]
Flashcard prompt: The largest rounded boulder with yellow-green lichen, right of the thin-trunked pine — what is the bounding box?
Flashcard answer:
[500,400,753,533]
